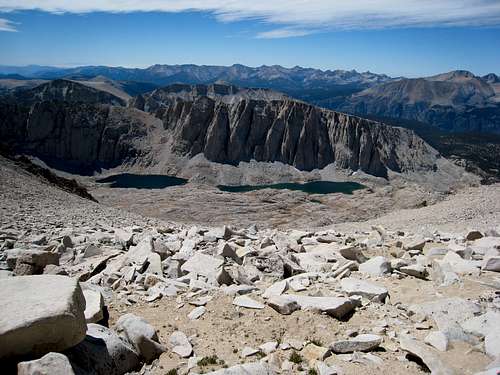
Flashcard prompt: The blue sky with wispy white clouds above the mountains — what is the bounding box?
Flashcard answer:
[0,0,500,76]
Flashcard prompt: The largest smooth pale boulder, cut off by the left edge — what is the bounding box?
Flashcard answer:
[0,275,87,358]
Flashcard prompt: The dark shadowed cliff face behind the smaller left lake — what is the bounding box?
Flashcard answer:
[0,101,147,173]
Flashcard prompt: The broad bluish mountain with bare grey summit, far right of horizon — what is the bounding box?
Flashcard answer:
[334,71,500,133]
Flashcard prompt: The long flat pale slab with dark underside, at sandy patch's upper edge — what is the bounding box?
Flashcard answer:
[283,294,355,319]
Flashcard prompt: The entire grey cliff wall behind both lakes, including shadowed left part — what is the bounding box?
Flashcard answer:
[0,82,446,177]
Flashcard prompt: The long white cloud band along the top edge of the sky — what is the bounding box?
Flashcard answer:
[0,0,500,38]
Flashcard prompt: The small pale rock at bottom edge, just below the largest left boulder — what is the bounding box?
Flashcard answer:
[17,353,75,375]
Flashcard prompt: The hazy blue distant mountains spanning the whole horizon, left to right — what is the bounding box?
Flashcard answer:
[0,65,500,134]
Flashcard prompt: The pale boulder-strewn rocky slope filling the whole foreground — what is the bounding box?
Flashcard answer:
[0,160,500,375]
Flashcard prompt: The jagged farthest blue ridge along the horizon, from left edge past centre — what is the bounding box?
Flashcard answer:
[0,64,391,91]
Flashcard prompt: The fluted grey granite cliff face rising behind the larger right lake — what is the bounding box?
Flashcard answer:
[132,85,437,176]
